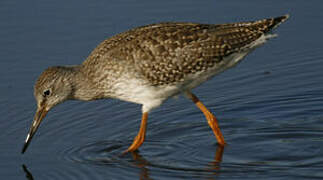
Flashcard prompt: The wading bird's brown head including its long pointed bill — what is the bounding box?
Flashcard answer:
[22,67,73,153]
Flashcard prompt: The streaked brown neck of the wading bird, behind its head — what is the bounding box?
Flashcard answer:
[68,65,104,101]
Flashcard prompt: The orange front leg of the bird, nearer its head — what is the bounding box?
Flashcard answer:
[124,112,148,153]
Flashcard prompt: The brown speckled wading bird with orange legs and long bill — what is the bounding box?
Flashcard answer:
[22,15,289,153]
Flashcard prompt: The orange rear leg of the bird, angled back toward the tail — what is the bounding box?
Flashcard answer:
[186,92,226,146]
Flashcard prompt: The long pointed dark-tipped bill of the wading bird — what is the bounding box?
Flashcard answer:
[21,106,48,154]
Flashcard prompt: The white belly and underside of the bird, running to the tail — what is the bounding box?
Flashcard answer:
[113,35,273,112]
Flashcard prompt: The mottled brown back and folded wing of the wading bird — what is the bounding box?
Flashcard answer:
[83,16,288,85]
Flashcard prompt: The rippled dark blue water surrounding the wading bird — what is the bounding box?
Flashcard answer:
[0,0,323,180]
